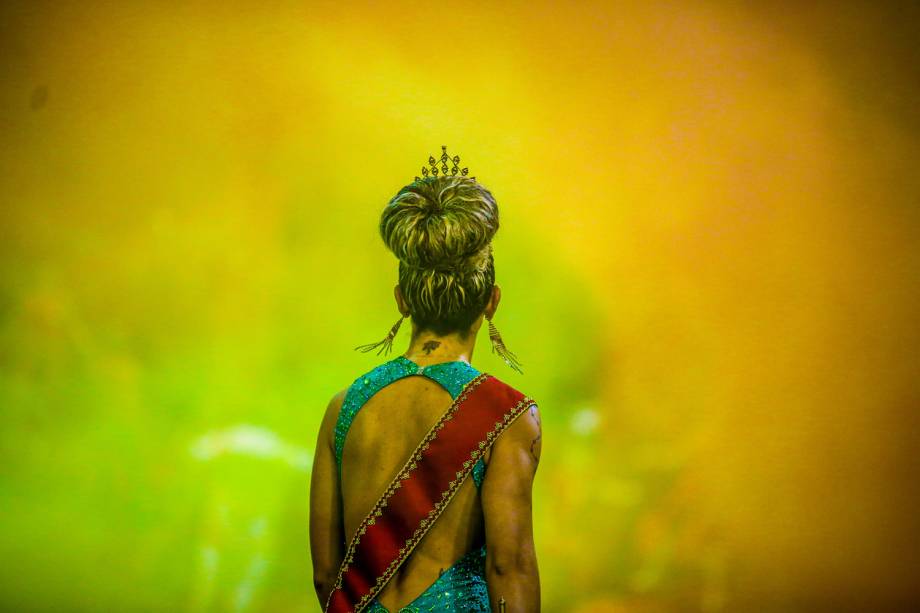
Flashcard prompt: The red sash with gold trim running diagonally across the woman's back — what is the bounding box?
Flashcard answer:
[325,373,534,613]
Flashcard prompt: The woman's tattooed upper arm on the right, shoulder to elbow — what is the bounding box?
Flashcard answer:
[482,404,542,572]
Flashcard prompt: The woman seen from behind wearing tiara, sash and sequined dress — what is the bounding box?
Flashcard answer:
[310,148,541,613]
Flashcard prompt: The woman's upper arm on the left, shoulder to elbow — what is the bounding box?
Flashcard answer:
[310,390,346,579]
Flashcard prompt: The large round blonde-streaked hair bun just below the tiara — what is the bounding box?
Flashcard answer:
[380,177,498,273]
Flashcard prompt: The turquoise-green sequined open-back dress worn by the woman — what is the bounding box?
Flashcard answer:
[335,356,491,613]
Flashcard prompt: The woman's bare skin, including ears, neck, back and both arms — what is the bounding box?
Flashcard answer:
[310,285,542,613]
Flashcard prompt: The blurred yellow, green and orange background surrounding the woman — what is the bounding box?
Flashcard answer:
[0,1,920,613]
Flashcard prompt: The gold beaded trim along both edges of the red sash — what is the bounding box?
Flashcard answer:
[324,373,534,613]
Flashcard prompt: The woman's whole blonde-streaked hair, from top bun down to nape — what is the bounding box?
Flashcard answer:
[380,176,498,335]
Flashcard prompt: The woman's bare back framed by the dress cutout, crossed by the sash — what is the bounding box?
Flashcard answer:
[341,376,488,611]
